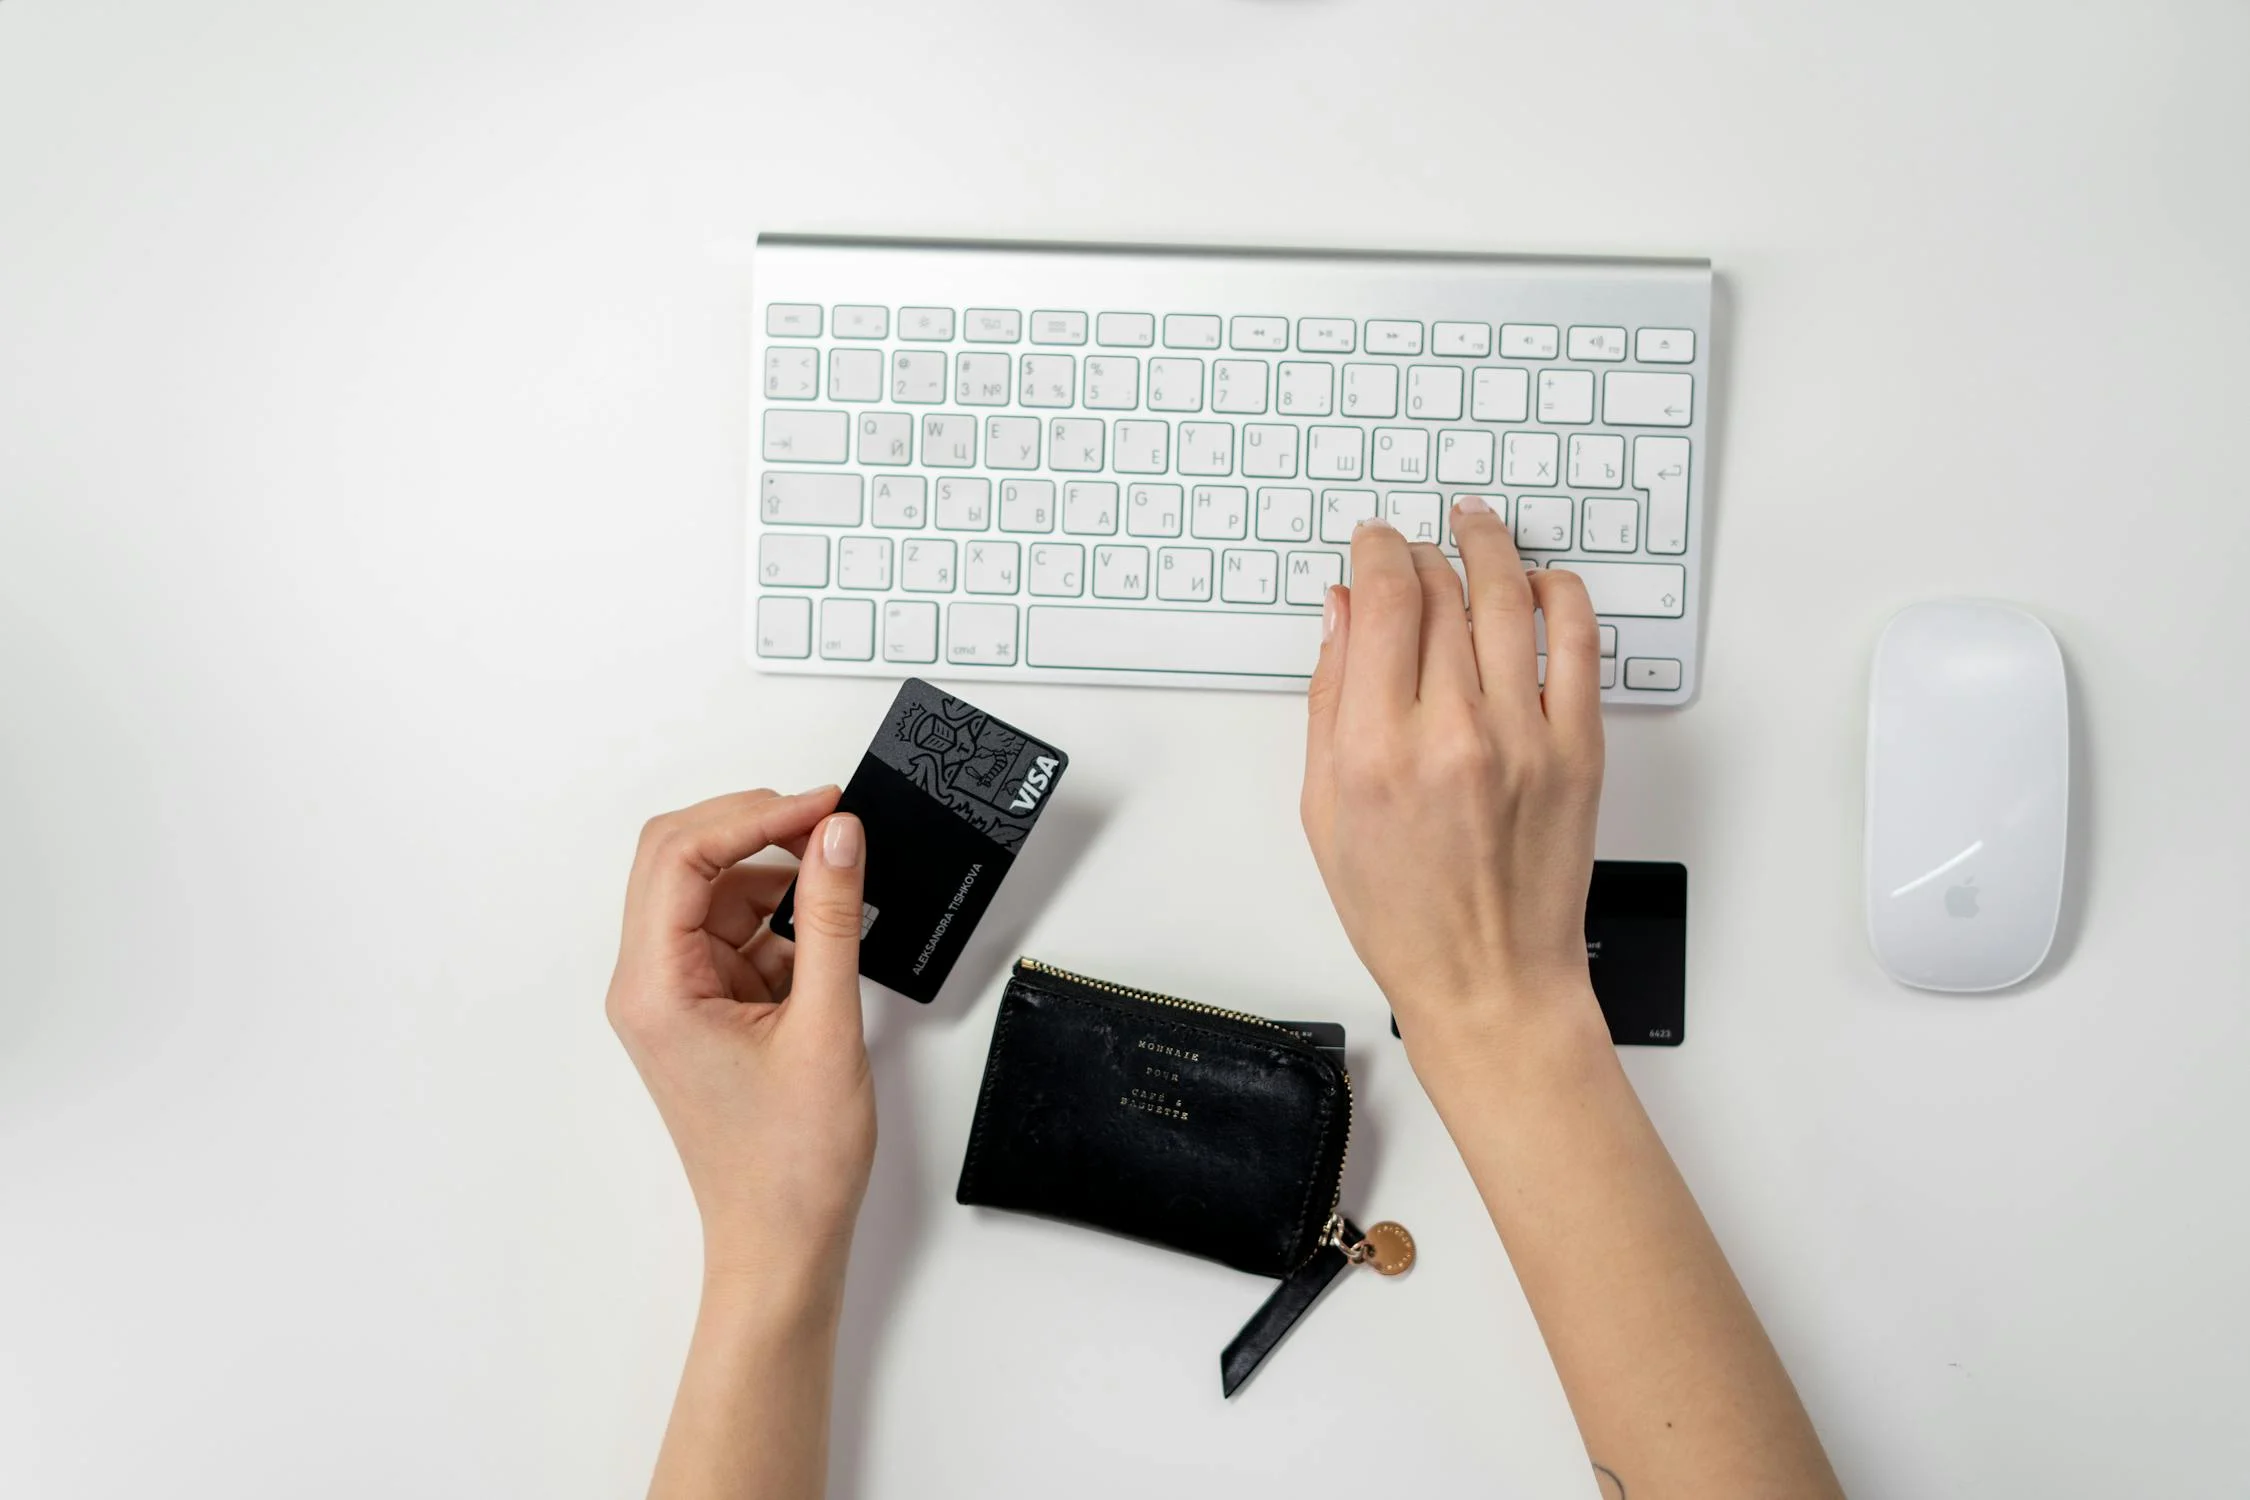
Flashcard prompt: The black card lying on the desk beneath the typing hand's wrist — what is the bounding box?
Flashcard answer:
[1391,859,1688,1048]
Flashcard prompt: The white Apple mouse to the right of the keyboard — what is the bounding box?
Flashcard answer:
[1868,598,2070,994]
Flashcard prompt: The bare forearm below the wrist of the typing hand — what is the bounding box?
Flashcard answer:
[1415,994,1841,1500]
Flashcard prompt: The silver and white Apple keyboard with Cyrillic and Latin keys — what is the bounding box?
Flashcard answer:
[747,234,1710,704]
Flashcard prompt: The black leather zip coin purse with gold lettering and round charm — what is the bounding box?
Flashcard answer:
[954,958,1413,1397]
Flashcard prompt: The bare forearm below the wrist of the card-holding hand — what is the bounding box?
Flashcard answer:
[648,1277,844,1500]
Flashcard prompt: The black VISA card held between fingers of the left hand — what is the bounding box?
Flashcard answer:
[772,677,1071,1005]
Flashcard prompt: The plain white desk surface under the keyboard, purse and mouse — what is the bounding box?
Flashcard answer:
[0,0,2250,1500]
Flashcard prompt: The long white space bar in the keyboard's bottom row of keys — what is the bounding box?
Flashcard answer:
[1024,605,1321,677]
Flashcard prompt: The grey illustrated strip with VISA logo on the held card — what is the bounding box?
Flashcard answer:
[869,679,1062,852]
